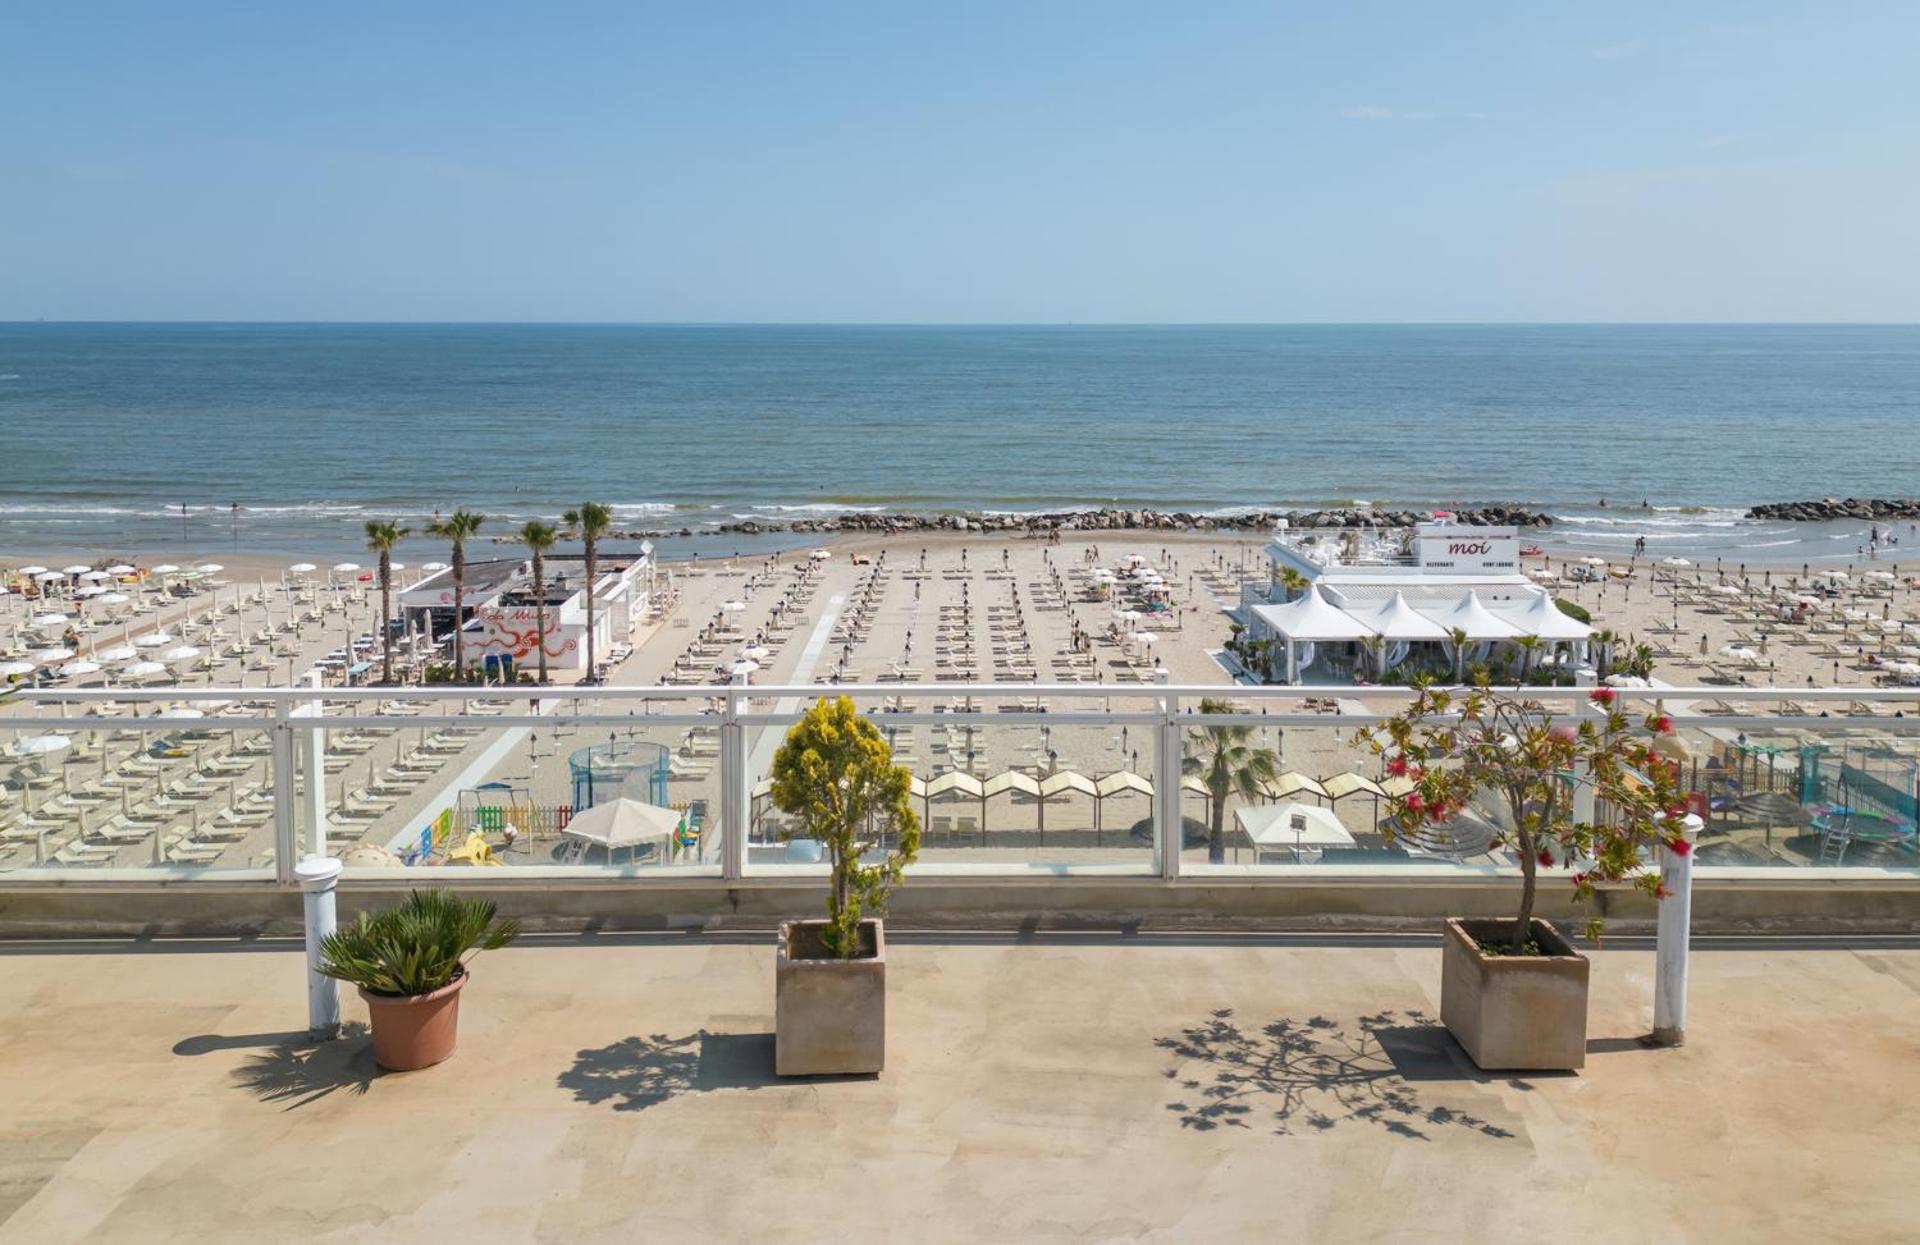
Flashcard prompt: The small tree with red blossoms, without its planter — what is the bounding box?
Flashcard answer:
[1359,684,1690,955]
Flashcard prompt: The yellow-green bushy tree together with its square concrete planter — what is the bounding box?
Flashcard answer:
[772,696,920,1076]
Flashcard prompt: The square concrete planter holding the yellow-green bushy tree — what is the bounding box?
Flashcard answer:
[774,920,887,1076]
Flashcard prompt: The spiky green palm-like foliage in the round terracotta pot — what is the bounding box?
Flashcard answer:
[321,890,520,997]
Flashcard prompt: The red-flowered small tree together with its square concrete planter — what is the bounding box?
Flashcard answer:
[1361,682,1690,1068]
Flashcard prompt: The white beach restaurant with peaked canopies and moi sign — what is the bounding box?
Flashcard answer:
[1240,523,1590,684]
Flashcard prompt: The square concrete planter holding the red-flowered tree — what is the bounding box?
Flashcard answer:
[1440,918,1588,1072]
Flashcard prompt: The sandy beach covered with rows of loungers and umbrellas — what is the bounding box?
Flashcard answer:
[0,532,1920,867]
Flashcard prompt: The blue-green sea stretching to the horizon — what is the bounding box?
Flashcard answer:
[0,323,1920,563]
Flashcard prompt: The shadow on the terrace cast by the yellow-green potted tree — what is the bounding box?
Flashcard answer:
[559,1030,780,1111]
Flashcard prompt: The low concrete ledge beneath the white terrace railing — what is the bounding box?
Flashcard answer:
[0,870,1920,938]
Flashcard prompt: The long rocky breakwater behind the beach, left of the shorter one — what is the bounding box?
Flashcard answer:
[579,505,1553,540]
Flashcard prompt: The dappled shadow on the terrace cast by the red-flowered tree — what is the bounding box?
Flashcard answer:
[1154,1009,1528,1141]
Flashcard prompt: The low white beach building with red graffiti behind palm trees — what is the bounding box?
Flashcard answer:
[399,548,655,671]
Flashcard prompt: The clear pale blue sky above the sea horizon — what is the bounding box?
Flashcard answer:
[0,0,1920,323]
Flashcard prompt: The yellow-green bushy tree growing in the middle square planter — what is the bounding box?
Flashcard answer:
[772,696,920,959]
